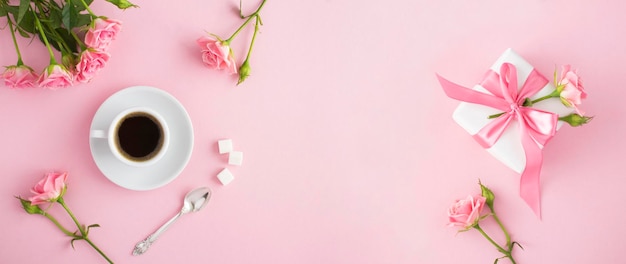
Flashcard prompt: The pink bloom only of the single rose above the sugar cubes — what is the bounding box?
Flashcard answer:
[196,36,237,74]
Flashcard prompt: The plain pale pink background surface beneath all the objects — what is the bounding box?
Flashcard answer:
[0,0,626,264]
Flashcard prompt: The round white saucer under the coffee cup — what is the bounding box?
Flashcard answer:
[89,86,193,191]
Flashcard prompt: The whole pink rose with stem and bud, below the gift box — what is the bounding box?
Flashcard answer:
[448,182,523,264]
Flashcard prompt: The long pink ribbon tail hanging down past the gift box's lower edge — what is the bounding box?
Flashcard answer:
[520,131,543,219]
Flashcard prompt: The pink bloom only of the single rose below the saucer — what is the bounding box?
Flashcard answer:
[28,172,67,205]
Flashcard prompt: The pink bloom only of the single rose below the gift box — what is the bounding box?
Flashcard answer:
[448,195,486,229]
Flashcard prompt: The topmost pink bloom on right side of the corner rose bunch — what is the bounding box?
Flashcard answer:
[85,17,122,51]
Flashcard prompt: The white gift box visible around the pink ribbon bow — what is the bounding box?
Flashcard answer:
[452,49,574,173]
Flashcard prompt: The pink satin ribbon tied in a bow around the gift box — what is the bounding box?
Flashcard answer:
[437,63,559,218]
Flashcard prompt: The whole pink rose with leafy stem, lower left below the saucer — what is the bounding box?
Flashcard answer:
[16,172,113,263]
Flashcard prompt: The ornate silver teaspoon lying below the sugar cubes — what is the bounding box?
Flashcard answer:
[133,187,211,256]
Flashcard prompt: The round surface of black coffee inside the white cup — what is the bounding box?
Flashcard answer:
[117,112,163,161]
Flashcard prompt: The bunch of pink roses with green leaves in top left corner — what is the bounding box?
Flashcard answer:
[0,0,136,89]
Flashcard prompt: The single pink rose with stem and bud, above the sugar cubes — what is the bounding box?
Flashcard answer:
[196,0,266,85]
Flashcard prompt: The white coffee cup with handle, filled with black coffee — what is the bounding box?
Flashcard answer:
[90,107,170,167]
